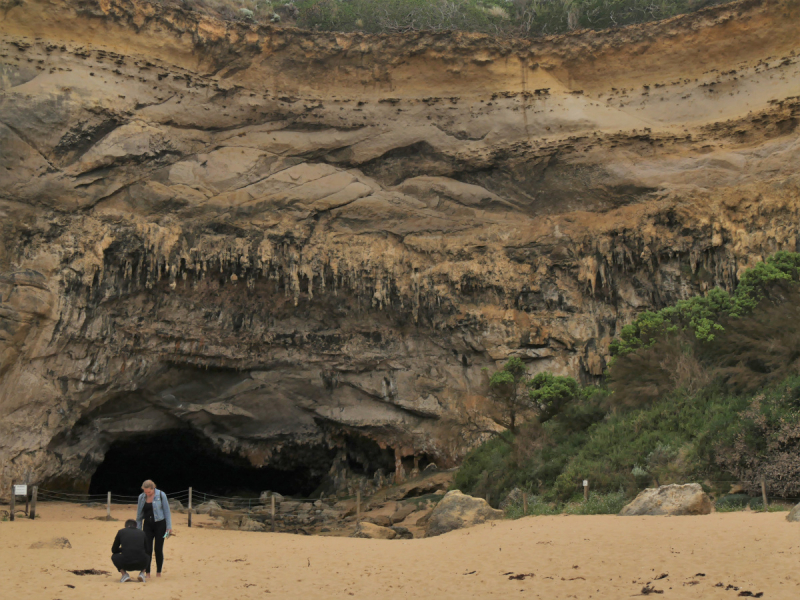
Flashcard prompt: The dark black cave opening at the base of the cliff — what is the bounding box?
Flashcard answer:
[89,429,335,498]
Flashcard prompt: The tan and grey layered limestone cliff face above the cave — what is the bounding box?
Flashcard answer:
[0,0,800,489]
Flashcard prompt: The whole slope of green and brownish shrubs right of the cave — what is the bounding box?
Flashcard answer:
[456,252,800,514]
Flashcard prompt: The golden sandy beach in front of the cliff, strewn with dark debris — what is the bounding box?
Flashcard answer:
[0,504,800,600]
